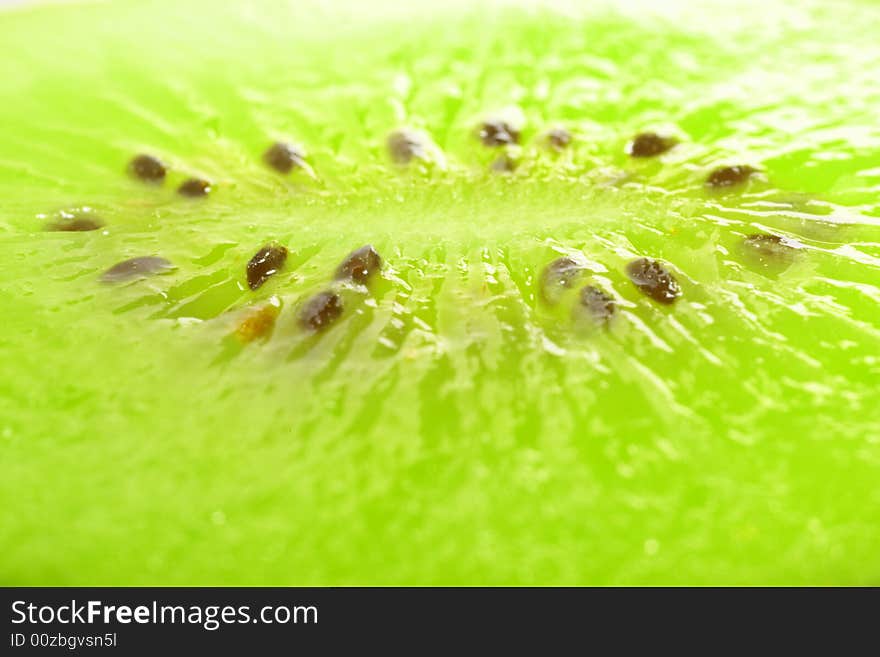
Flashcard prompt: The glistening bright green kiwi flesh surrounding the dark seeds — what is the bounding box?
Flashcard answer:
[0,1,880,584]
